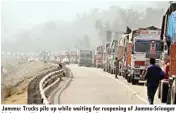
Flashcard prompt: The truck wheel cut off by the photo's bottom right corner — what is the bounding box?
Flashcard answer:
[171,80,176,104]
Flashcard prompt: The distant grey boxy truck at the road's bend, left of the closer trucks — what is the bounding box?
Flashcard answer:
[78,50,92,67]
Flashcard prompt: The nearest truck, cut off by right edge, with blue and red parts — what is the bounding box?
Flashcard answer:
[158,3,176,104]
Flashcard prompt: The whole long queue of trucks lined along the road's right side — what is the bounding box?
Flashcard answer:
[37,3,176,104]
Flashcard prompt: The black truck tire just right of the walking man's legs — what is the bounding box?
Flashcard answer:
[160,82,169,103]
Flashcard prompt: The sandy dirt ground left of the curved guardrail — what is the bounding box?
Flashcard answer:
[1,60,56,104]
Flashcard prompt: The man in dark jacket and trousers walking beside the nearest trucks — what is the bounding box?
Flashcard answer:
[145,58,164,104]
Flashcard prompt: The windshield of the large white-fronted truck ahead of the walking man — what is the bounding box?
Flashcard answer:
[134,40,151,52]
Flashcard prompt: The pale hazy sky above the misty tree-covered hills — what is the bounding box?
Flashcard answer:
[1,0,168,41]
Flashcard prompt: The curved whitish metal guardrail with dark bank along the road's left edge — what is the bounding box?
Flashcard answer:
[27,62,64,104]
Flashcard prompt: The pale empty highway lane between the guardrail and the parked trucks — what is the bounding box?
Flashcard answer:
[54,64,161,104]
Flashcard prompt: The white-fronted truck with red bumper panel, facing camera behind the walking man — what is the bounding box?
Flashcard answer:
[124,26,161,84]
